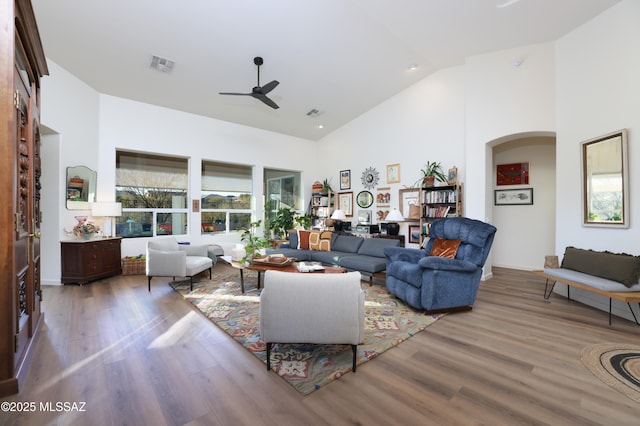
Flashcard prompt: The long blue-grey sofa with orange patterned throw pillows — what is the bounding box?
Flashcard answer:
[267,232,400,283]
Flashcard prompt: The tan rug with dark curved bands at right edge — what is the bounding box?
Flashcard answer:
[582,343,640,402]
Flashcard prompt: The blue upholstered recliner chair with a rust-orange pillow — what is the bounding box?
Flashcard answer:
[384,217,496,312]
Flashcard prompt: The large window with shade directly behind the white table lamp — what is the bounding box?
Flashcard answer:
[116,151,189,238]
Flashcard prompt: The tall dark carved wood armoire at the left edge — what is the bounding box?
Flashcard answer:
[0,0,48,397]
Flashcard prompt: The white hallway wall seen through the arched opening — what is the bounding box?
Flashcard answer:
[491,137,556,270]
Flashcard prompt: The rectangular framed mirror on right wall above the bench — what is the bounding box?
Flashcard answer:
[581,129,629,228]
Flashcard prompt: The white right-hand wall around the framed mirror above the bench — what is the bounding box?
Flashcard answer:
[556,0,640,318]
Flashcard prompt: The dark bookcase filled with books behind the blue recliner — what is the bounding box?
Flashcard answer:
[420,184,463,244]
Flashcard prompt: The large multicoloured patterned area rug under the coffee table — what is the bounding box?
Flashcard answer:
[171,262,443,395]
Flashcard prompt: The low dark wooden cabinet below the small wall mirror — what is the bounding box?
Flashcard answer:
[60,238,122,284]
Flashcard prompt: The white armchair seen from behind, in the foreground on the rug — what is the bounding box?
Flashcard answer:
[260,271,364,371]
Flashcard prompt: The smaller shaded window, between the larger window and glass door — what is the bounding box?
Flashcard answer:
[200,161,253,234]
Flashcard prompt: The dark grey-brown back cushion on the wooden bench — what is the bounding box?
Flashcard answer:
[561,247,640,287]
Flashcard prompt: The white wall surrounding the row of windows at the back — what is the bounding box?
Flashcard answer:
[98,95,318,255]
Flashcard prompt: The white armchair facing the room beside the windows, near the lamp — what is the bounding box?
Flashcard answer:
[147,237,213,291]
